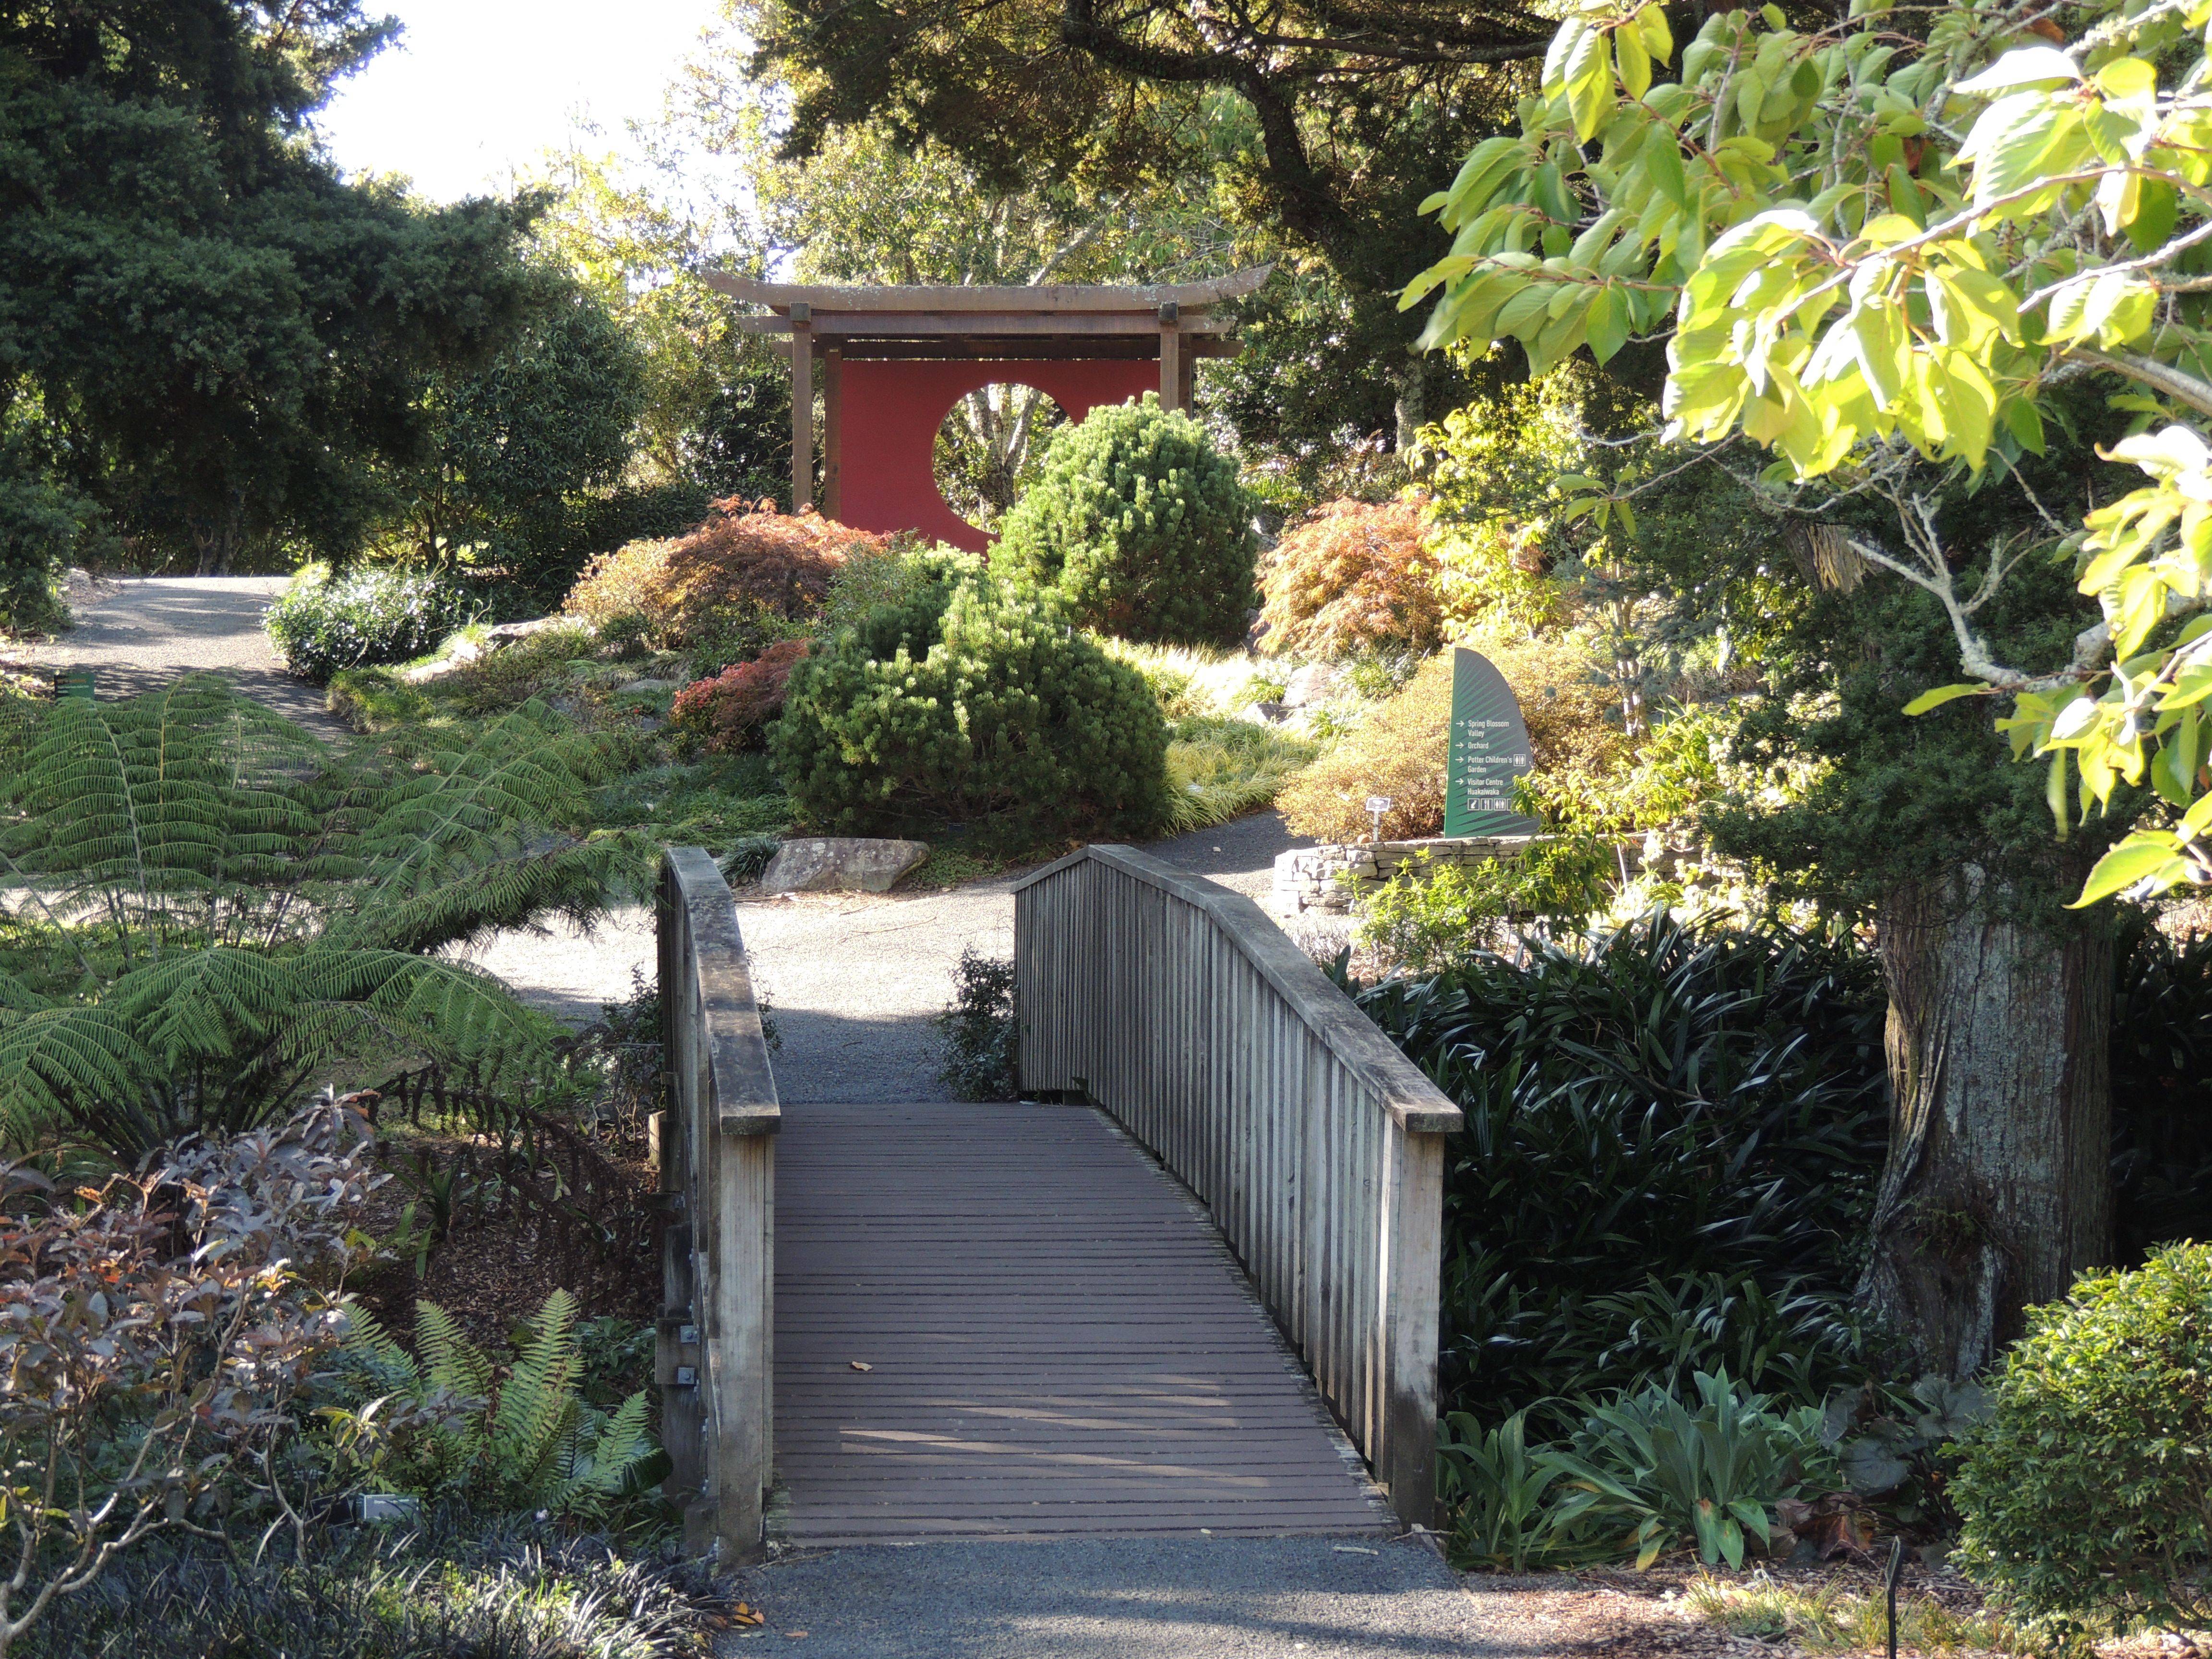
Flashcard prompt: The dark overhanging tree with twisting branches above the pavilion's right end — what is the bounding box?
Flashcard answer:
[734,0,1551,480]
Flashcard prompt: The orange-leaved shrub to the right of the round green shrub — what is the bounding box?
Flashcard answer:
[1261,493,1444,657]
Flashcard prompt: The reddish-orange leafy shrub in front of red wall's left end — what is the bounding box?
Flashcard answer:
[564,495,889,655]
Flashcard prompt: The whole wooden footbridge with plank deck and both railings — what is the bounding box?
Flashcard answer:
[659,847,1460,1562]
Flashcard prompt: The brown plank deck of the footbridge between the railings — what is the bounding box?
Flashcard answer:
[774,1104,1387,1544]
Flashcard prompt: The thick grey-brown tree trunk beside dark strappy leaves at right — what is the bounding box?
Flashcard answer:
[1858,867,2113,1380]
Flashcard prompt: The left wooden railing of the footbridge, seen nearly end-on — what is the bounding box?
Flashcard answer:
[655,847,783,1564]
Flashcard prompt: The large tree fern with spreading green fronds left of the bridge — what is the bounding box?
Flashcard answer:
[0,674,646,1157]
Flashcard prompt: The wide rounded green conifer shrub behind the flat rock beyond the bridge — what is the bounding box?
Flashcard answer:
[770,577,1168,834]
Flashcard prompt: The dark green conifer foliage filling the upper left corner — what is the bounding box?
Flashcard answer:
[0,0,544,589]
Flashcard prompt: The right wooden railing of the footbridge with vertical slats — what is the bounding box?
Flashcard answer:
[1015,845,1462,1527]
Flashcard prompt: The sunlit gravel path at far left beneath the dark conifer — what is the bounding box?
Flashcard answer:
[11,575,345,736]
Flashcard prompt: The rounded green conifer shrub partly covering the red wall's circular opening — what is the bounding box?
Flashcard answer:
[991,394,1256,646]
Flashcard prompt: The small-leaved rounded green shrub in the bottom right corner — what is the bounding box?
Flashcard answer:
[1951,1243,2212,1635]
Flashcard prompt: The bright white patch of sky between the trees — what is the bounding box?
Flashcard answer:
[316,0,721,201]
